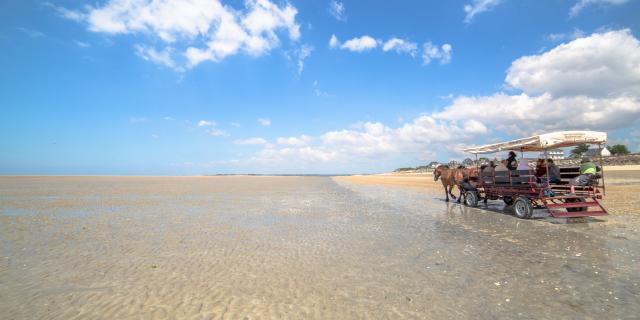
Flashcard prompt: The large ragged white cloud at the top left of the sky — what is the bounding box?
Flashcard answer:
[54,0,300,71]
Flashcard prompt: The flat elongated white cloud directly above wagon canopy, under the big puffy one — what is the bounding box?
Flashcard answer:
[434,93,640,136]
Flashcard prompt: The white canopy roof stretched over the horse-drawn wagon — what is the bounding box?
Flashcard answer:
[464,131,607,154]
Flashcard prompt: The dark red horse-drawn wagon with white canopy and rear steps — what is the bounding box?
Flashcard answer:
[452,131,607,219]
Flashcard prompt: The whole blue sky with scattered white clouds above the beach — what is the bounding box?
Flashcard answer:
[0,0,640,175]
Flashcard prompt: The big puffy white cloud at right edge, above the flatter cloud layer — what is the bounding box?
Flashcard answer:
[506,29,640,97]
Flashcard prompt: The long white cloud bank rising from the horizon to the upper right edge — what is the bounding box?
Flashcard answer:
[226,30,640,172]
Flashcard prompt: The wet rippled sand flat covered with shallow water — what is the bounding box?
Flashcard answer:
[0,177,640,319]
